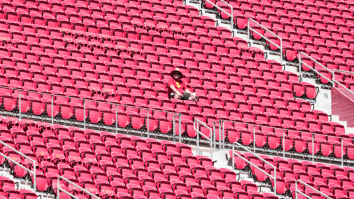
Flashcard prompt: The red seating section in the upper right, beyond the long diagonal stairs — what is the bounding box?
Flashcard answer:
[212,0,354,84]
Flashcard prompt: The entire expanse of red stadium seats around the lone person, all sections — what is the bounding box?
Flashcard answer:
[0,0,354,199]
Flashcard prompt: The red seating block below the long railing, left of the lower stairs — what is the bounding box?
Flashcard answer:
[0,118,284,199]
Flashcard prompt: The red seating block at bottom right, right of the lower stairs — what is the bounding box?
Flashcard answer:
[229,151,354,199]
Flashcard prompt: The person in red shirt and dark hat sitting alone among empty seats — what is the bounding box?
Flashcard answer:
[168,68,196,100]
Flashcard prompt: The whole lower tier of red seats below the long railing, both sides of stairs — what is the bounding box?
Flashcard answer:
[0,118,354,199]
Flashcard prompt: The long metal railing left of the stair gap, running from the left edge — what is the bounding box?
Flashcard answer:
[0,86,182,142]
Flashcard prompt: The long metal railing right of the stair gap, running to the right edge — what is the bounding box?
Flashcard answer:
[213,118,354,167]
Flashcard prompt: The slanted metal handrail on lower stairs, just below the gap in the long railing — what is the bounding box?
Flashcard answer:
[231,143,277,194]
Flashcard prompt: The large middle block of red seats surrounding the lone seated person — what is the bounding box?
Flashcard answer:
[0,0,345,162]
